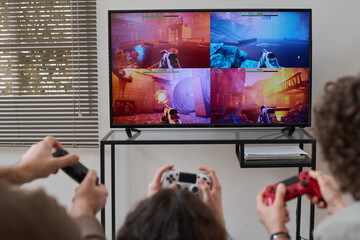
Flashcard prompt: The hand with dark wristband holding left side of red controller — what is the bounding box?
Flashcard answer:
[256,183,290,235]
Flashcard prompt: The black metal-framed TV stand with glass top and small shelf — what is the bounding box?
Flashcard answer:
[100,128,316,239]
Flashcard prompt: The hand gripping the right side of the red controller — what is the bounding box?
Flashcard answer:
[308,170,348,214]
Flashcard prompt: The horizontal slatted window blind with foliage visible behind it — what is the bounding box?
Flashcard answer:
[0,0,98,147]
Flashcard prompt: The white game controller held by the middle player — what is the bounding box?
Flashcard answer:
[162,169,211,199]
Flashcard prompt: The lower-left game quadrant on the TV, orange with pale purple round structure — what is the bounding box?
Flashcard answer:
[112,68,210,124]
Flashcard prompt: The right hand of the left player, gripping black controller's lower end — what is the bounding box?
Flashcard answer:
[70,169,108,218]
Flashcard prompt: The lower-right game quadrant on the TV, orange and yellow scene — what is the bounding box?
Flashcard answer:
[210,68,309,124]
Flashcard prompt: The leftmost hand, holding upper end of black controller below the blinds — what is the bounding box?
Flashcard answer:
[14,136,79,183]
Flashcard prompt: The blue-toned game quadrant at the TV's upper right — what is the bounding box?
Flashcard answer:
[210,12,310,68]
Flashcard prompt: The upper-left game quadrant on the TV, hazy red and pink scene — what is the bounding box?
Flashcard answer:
[111,12,210,70]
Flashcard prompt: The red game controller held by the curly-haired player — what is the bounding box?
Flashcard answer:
[265,171,324,206]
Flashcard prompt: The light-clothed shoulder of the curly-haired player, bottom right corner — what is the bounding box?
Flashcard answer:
[314,202,360,240]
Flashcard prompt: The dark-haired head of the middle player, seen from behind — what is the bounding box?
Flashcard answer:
[117,189,226,240]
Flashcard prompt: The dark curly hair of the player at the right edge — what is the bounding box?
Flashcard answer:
[315,77,360,200]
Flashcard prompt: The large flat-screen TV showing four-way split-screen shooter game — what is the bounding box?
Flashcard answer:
[108,9,311,128]
